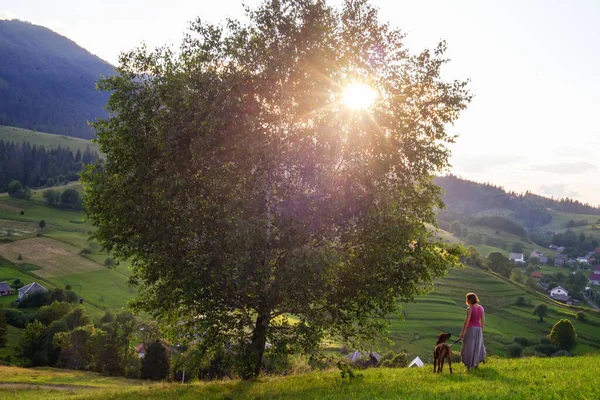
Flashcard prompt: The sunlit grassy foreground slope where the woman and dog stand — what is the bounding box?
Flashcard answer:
[0,356,600,400]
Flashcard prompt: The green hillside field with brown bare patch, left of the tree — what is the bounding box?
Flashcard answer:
[0,183,135,328]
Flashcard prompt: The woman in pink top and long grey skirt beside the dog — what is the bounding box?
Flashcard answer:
[460,293,485,370]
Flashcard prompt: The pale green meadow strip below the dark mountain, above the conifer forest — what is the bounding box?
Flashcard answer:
[0,125,98,153]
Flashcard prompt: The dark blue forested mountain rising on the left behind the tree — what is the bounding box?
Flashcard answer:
[0,20,114,139]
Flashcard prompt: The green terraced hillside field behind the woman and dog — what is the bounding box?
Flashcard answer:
[377,268,600,360]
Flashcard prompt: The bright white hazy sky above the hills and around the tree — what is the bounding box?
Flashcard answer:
[0,0,600,205]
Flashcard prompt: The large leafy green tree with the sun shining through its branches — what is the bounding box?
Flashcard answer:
[83,0,470,377]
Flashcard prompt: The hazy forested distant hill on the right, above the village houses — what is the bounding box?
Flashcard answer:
[435,175,600,229]
